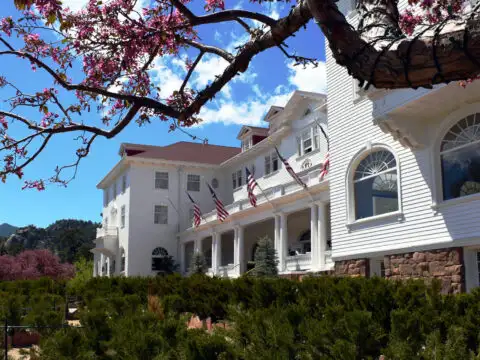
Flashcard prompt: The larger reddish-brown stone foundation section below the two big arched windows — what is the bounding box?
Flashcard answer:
[384,248,465,294]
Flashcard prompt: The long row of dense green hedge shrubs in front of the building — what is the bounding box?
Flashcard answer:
[4,276,480,360]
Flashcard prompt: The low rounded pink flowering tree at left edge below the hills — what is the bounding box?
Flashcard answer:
[0,250,75,281]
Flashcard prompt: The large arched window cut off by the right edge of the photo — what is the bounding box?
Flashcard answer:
[440,113,480,200]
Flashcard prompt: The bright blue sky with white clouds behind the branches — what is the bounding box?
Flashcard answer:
[0,0,326,227]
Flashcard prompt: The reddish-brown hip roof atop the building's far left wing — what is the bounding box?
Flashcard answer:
[121,141,241,165]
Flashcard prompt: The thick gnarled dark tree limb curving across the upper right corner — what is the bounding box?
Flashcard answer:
[306,0,480,89]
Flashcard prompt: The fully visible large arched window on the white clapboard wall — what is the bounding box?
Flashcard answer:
[353,149,399,220]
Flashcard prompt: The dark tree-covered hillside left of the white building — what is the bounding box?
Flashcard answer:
[0,219,100,263]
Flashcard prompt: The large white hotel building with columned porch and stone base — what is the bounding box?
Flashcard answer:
[93,0,480,292]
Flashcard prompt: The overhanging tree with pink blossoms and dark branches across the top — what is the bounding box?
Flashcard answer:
[0,0,480,186]
